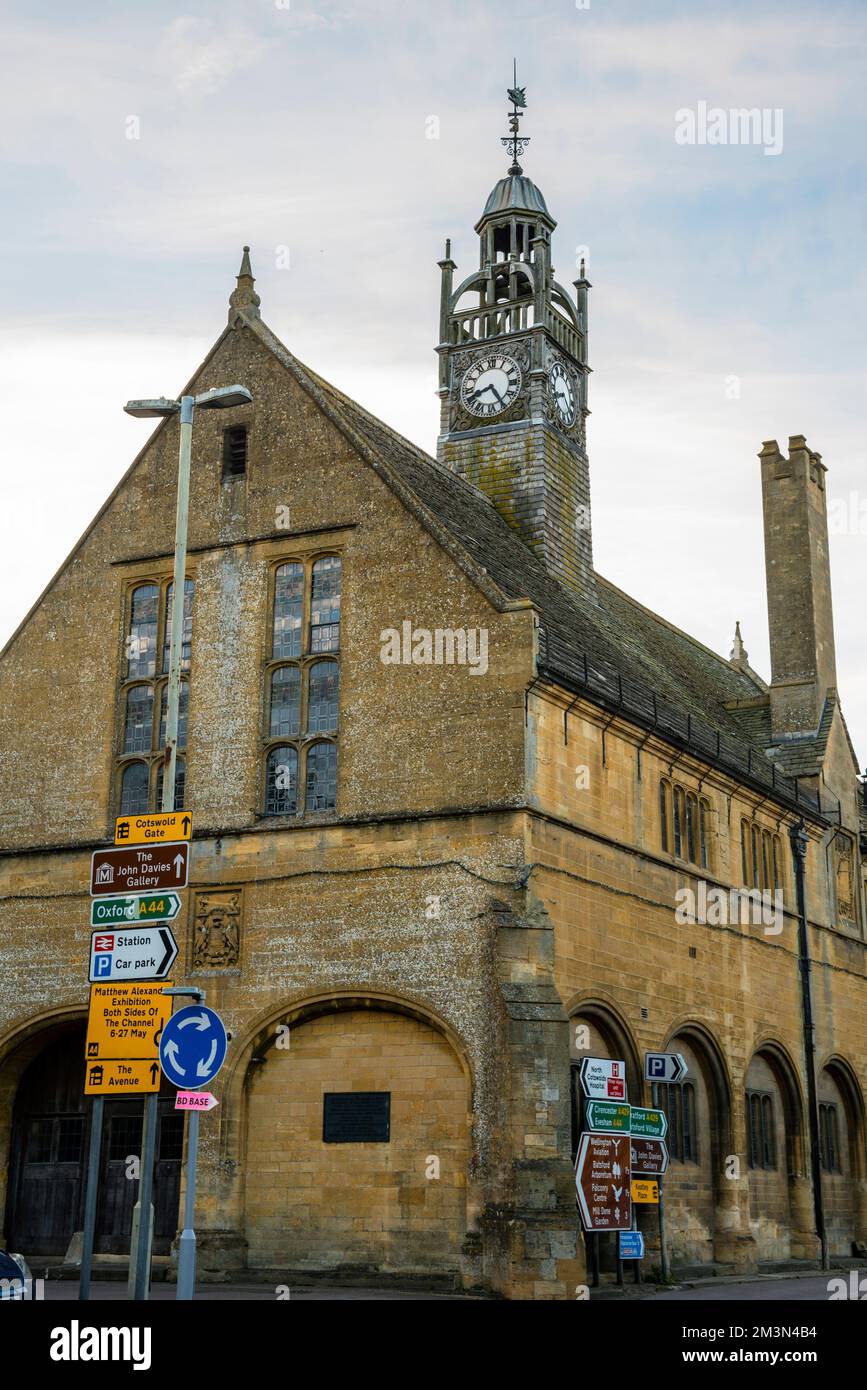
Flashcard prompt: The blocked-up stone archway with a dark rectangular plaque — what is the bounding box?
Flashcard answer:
[243,997,471,1276]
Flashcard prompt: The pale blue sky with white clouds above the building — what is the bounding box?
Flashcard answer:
[0,0,867,766]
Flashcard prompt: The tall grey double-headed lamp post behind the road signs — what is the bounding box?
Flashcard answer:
[124,385,253,1301]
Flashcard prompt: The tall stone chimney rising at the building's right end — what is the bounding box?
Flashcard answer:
[759,435,836,737]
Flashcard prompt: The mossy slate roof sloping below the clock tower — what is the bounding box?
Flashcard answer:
[250,322,828,817]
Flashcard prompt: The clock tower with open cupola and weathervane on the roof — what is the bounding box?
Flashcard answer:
[436,76,595,602]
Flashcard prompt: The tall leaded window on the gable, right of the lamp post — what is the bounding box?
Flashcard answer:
[263,555,342,816]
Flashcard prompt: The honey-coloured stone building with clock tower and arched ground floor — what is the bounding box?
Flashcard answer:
[0,111,867,1298]
